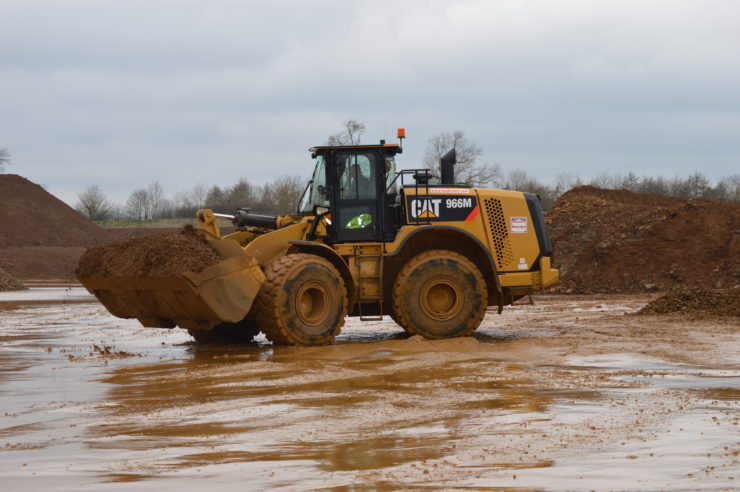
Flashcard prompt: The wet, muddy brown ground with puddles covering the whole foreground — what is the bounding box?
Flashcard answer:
[0,294,740,490]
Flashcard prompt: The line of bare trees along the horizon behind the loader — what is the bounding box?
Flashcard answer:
[24,119,740,220]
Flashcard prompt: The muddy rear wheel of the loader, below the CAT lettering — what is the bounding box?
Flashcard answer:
[393,249,488,339]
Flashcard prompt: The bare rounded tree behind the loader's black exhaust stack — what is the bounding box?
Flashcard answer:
[422,130,502,186]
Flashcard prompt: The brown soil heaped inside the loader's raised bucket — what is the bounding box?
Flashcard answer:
[75,226,223,278]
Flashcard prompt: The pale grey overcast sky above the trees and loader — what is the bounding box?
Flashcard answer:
[0,0,740,204]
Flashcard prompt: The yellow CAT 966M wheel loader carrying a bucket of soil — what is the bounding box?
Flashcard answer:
[79,129,558,345]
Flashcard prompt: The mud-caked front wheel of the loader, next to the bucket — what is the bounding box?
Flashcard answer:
[256,253,347,345]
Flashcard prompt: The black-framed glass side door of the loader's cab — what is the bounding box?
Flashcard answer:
[332,149,384,242]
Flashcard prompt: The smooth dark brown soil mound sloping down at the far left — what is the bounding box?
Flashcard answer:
[0,174,110,248]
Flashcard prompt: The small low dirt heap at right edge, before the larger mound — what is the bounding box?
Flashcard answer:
[638,287,740,316]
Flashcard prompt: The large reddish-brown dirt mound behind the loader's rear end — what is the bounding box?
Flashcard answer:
[547,186,740,293]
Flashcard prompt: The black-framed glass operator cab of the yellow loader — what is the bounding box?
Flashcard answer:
[298,142,403,243]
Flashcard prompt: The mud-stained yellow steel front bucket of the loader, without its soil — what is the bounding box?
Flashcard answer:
[79,239,265,329]
